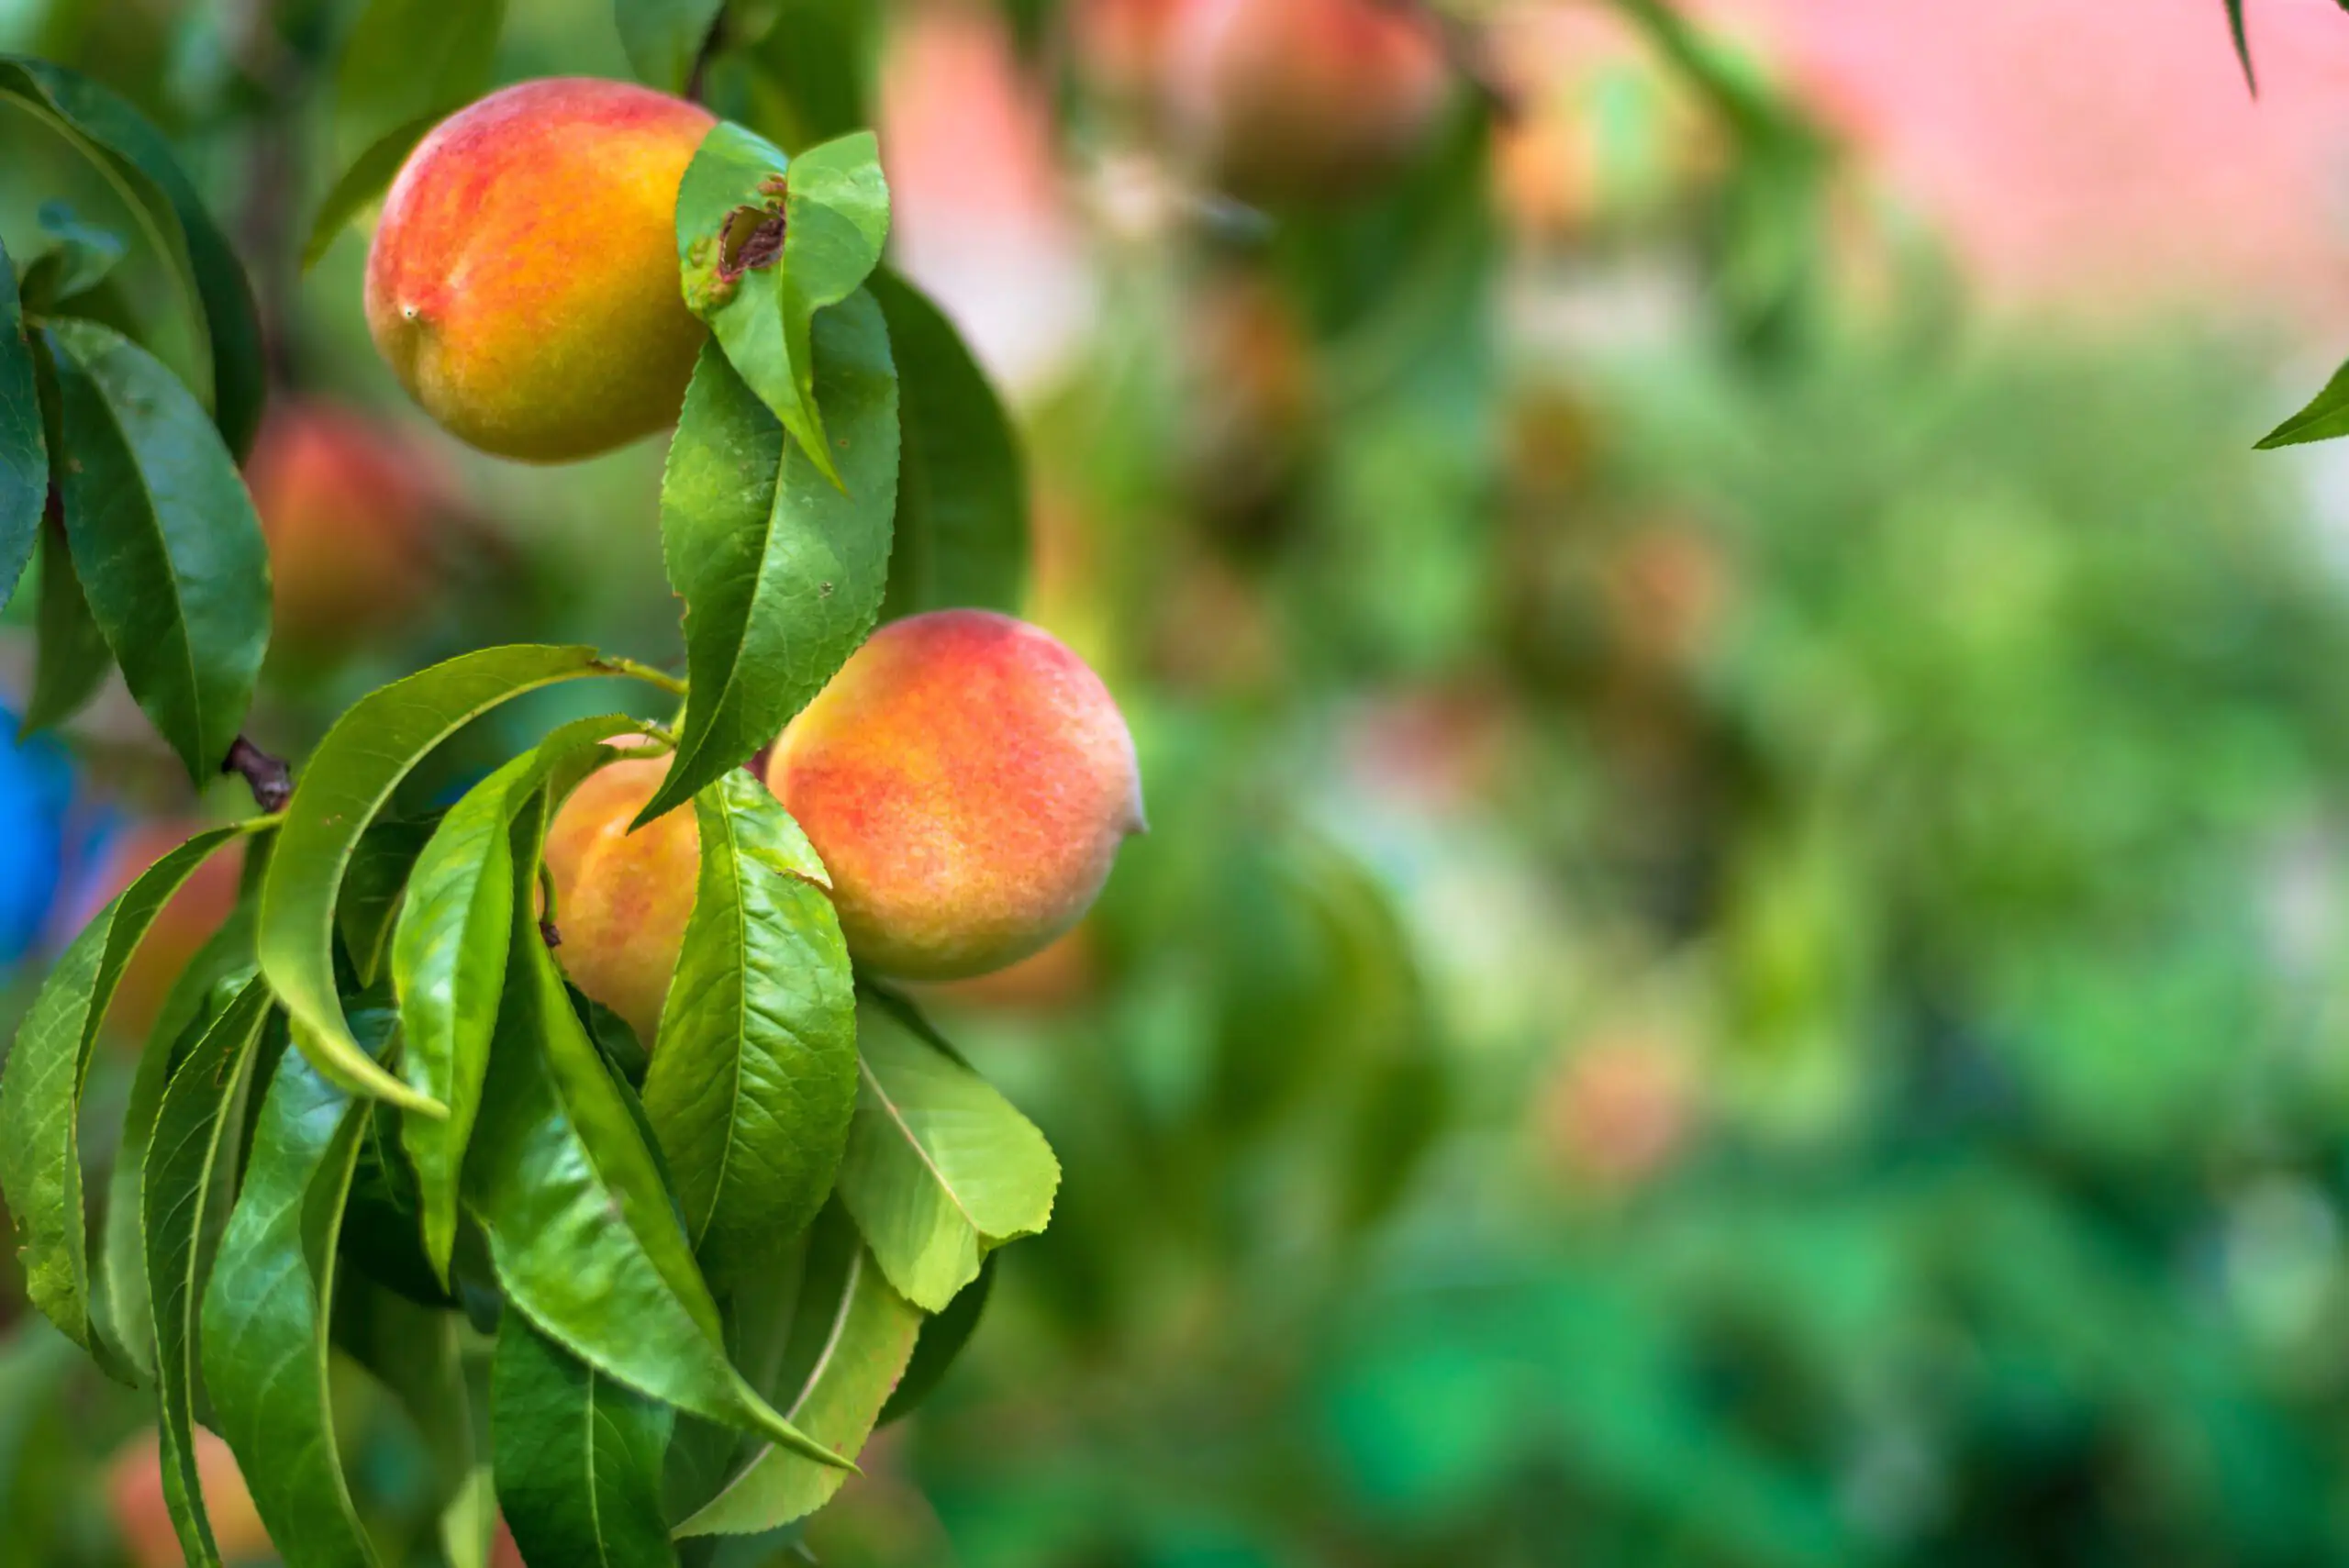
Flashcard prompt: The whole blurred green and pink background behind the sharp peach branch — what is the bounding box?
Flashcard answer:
[14,0,2349,1568]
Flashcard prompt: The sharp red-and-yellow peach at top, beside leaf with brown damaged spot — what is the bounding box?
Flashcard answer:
[366,77,714,462]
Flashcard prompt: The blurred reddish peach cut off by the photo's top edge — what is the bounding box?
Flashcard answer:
[1167,0,1452,199]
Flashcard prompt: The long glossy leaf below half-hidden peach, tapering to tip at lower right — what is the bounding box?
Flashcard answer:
[465,857,850,1458]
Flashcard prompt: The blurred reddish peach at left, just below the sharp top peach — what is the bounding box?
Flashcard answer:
[244,404,446,660]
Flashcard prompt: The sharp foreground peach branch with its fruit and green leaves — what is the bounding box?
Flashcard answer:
[0,0,1140,1568]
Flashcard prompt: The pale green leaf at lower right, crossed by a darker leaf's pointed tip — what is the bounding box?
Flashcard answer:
[676,1207,921,1535]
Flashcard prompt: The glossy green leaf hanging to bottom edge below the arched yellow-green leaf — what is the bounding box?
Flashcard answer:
[202,1028,376,1568]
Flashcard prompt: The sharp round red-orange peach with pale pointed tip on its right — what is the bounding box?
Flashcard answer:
[766,610,1141,979]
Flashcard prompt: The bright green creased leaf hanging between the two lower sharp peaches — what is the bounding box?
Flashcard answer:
[643,768,857,1273]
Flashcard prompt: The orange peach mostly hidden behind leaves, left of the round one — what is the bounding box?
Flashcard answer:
[547,756,702,1050]
